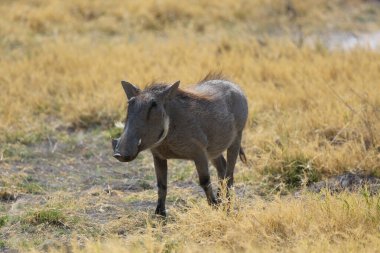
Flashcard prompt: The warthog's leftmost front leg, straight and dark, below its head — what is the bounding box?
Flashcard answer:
[153,155,168,216]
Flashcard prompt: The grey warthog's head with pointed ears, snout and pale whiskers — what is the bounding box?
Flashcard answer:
[112,81,179,162]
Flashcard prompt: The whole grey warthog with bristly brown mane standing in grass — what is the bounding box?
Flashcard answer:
[112,74,248,216]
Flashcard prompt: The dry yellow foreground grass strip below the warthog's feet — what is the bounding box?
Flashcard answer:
[25,193,380,252]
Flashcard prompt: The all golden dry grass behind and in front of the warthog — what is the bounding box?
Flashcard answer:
[0,0,380,252]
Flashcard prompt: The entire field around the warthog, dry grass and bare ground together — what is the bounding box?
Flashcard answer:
[0,0,380,252]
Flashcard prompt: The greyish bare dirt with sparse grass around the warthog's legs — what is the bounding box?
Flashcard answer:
[0,129,380,252]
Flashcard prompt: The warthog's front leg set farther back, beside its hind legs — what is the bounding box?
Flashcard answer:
[194,156,218,205]
